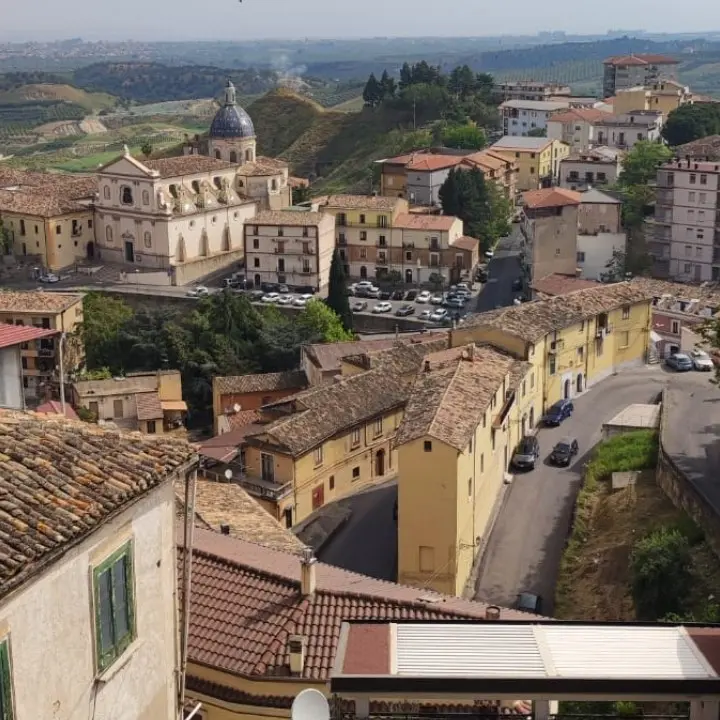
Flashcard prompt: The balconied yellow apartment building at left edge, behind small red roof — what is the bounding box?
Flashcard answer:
[0,290,85,407]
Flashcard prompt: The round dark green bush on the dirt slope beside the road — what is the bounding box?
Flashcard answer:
[630,527,690,620]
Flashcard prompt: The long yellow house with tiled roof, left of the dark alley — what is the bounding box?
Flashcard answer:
[241,336,448,527]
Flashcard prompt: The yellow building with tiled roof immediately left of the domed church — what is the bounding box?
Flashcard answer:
[0,169,97,270]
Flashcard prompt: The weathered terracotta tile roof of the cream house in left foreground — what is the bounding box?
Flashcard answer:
[0,412,196,596]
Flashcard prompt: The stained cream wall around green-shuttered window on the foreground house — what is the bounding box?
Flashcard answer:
[0,482,177,720]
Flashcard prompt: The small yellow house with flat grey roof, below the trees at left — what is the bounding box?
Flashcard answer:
[72,370,187,435]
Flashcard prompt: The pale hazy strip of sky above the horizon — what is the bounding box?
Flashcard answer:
[0,0,720,40]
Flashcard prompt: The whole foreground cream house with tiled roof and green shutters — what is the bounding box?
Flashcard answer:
[0,412,197,720]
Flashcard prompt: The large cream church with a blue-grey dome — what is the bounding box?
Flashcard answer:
[88,81,292,285]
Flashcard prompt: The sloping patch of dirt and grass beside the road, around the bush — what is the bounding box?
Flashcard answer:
[555,430,720,621]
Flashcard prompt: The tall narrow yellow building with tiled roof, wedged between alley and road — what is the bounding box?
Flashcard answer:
[395,343,532,595]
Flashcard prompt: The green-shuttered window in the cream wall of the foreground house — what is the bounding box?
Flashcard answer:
[93,542,135,670]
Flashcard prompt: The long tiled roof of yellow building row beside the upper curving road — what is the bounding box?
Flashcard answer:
[463,282,652,342]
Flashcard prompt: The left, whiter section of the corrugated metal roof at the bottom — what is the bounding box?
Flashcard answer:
[397,623,546,677]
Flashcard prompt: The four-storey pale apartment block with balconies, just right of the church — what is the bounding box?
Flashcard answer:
[244,210,335,296]
